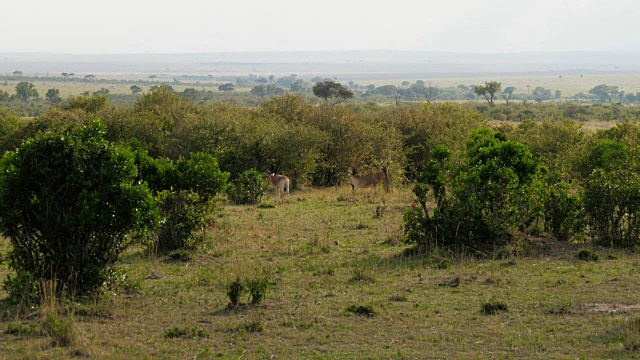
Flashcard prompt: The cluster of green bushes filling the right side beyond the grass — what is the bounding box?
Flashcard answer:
[405,120,640,250]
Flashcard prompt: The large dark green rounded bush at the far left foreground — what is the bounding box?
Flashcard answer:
[0,121,157,294]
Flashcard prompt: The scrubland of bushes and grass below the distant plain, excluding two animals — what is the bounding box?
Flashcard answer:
[0,86,640,359]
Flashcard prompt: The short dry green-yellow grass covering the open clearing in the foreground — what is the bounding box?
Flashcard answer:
[0,186,640,359]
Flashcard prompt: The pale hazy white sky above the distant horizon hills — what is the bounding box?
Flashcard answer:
[0,0,640,54]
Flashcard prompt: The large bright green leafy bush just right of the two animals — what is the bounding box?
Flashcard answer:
[404,129,545,250]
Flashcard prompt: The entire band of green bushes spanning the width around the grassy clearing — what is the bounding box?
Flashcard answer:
[0,86,640,299]
